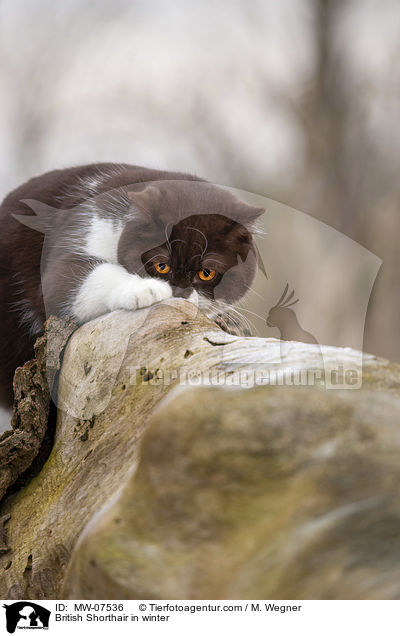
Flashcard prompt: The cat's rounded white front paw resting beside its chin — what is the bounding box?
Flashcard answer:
[116,278,172,310]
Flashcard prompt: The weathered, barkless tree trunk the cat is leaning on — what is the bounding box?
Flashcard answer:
[0,301,400,599]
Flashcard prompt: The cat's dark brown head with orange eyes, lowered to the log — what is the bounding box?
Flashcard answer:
[118,181,264,303]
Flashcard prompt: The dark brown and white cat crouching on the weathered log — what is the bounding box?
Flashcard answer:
[0,163,265,408]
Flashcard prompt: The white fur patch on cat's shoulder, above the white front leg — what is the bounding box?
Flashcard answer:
[84,217,124,263]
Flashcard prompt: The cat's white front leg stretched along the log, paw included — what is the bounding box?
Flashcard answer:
[72,263,172,322]
